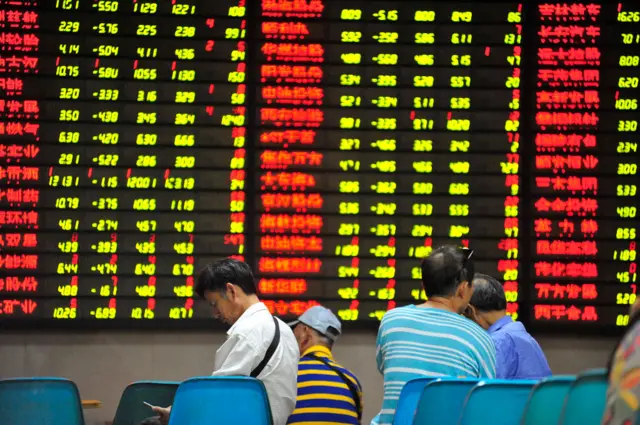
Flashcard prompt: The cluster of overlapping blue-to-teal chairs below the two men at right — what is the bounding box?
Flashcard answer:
[394,369,607,425]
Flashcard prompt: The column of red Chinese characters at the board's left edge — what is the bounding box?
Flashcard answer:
[0,0,44,317]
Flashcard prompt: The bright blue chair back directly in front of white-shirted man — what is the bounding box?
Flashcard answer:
[169,376,272,425]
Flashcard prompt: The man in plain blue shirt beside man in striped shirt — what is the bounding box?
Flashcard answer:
[467,273,551,379]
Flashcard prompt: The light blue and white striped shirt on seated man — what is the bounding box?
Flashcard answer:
[371,305,496,425]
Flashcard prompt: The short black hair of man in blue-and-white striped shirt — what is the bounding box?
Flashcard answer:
[420,245,468,297]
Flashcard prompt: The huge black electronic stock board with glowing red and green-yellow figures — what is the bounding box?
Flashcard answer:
[0,0,640,332]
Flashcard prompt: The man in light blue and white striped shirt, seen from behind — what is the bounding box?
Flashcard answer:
[371,245,496,425]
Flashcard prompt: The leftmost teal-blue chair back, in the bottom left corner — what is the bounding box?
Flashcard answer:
[0,377,84,425]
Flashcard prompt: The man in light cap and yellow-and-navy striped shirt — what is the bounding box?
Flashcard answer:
[287,306,362,425]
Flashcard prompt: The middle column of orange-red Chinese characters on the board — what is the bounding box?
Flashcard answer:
[258,0,324,294]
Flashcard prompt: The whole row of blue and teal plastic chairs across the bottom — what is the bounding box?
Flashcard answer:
[0,369,607,425]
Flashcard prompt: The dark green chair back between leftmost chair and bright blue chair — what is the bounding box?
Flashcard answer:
[113,381,180,425]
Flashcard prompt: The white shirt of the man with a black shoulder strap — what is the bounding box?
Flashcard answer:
[212,303,300,425]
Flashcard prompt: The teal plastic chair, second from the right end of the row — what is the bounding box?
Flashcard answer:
[521,375,576,425]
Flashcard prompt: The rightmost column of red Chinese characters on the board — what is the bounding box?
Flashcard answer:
[532,3,602,321]
